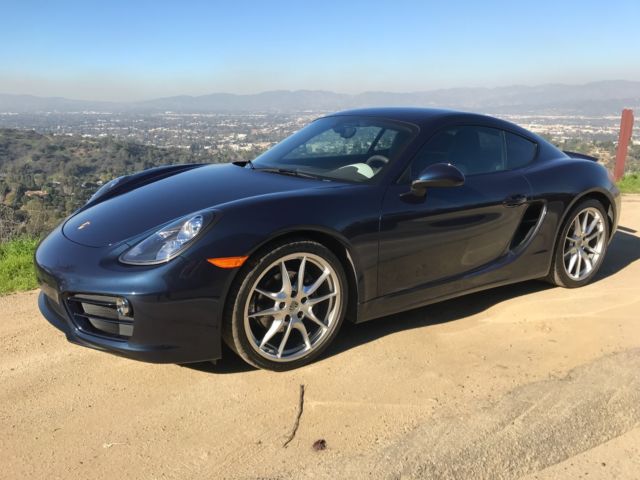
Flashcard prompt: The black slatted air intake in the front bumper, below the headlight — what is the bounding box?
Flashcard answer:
[67,294,133,340]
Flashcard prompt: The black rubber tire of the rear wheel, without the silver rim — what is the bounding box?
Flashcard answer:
[546,199,610,288]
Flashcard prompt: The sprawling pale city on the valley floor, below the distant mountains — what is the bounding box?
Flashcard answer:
[0,111,638,153]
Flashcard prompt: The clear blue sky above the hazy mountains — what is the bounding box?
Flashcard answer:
[0,0,640,101]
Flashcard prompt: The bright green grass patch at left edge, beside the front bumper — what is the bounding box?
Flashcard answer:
[0,238,38,295]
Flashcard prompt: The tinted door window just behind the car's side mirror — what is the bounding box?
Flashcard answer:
[409,126,507,179]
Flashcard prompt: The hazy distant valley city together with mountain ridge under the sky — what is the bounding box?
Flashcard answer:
[0,80,640,153]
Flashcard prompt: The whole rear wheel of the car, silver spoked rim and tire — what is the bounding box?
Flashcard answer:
[547,199,609,288]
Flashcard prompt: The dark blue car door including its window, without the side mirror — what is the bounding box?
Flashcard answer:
[378,126,531,295]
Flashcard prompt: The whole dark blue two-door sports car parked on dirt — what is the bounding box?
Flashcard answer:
[36,109,620,370]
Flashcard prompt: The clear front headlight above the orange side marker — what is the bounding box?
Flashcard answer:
[120,213,211,265]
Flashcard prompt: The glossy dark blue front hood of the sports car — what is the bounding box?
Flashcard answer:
[62,164,336,247]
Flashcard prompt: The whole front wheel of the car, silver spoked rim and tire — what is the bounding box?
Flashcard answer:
[223,239,348,371]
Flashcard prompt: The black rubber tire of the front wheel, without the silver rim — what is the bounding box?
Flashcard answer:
[223,240,349,371]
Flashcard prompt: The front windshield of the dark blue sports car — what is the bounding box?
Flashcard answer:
[252,116,415,182]
